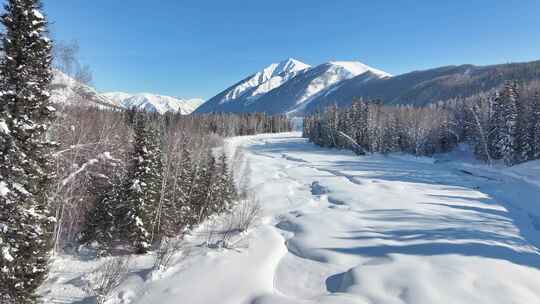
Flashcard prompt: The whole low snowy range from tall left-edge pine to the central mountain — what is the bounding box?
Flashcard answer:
[51,70,204,115]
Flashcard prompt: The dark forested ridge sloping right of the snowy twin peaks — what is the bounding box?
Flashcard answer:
[303,61,540,113]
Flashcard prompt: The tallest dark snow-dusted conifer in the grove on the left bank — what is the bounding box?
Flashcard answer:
[115,113,162,253]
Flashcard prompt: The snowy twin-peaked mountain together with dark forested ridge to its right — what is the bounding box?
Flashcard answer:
[195,59,540,116]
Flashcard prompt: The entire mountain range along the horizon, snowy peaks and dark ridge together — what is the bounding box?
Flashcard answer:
[52,59,540,116]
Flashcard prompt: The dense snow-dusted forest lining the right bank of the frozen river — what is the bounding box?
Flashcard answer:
[303,81,540,166]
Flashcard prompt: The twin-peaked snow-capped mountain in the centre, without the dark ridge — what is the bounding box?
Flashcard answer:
[196,59,390,114]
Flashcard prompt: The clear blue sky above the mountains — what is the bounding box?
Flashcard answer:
[44,0,540,98]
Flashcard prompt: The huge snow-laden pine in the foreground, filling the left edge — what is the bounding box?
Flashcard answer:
[0,0,54,304]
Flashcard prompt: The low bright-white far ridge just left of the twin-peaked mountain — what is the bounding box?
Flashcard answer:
[102,92,204,115]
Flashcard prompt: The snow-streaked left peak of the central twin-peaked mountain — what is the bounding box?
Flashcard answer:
[220,58,310,104]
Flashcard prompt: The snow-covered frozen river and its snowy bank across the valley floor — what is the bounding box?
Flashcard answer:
[43,133,540,304]
